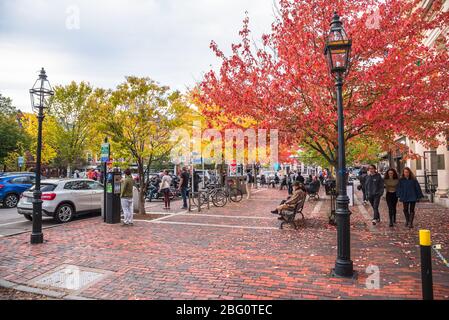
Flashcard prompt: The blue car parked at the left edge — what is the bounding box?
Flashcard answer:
[0,173,36,208]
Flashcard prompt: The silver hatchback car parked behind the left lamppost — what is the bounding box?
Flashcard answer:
[17,179,104,223]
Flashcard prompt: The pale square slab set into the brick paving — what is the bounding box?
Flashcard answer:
[32,265,111,291]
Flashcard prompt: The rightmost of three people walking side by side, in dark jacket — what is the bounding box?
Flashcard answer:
[396,168,424,229]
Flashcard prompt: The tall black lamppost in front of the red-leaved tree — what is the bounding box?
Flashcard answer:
[325,13,354,277]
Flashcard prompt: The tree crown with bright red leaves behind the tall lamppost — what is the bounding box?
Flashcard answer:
[199,0,449,166]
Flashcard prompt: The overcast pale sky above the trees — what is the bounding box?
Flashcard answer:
[0,0,274,111]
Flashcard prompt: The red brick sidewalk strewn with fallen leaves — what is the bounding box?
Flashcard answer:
[0,189,449,300]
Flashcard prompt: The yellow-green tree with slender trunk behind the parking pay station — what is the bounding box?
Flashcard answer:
[96,77,189,214]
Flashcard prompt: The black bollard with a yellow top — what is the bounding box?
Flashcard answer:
[419,230,433,300]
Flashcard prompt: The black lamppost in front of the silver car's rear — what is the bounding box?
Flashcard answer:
[30,68,54,244]
